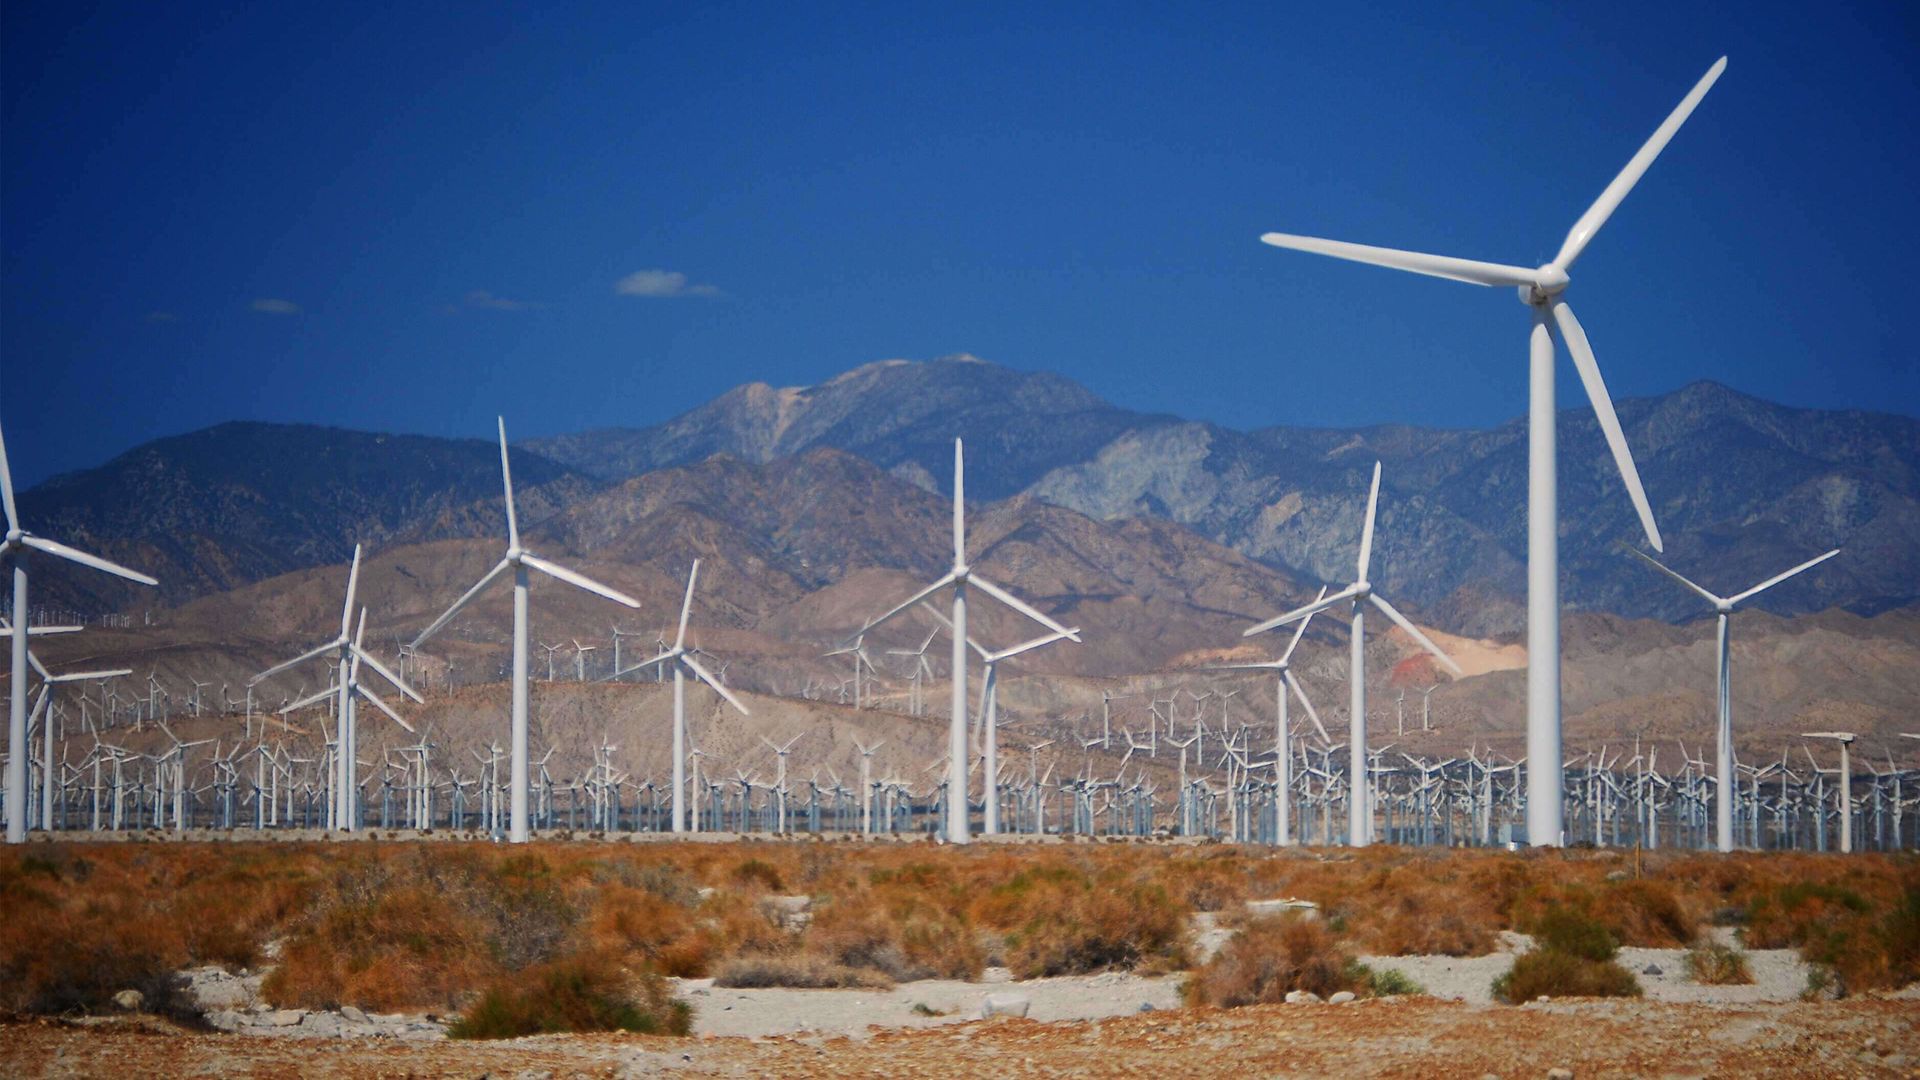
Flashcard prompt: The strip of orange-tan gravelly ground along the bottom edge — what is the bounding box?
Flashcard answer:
[0,997,1920,1080]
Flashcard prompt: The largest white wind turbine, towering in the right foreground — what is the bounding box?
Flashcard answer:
[1261,56,1726,846]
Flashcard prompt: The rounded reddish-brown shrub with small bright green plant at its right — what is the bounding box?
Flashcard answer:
[1181,915,1371,1009]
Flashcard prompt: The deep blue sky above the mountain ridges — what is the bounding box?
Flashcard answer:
[0,2,1920,484]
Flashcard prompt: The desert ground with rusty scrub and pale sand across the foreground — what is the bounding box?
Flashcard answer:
[0,838,1920,1076]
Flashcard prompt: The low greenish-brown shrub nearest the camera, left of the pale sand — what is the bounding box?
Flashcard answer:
[447,953,693,1040]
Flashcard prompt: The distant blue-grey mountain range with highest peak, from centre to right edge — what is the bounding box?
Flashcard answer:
[534,357,1920,634]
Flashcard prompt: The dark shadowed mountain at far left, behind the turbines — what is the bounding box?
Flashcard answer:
[19,423,599,611]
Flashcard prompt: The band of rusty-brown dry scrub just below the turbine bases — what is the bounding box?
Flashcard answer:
[0,842,1920,1013]
